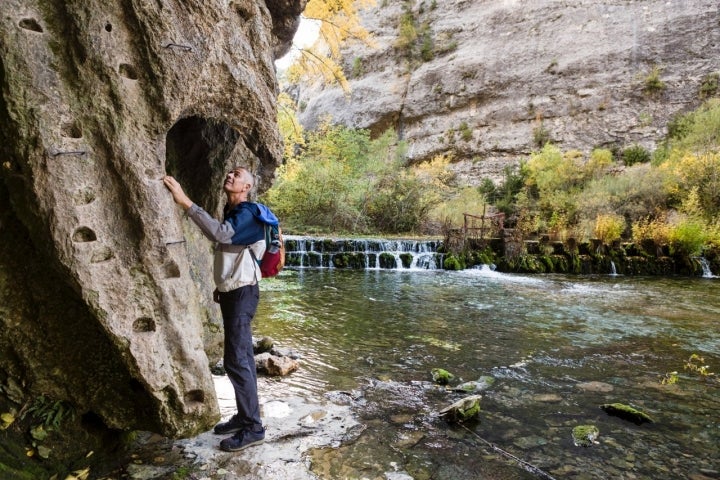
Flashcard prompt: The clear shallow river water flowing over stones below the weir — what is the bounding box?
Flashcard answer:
[255,268,720,480]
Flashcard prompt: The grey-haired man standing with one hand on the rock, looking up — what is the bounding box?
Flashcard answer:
[163,167,265,452]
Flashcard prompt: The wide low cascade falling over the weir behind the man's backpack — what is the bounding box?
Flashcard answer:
[285,235,443,270]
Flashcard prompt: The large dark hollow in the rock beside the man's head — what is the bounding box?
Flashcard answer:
[165,116,240,212]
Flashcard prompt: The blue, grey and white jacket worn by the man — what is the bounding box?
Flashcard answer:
[187,202,277,292]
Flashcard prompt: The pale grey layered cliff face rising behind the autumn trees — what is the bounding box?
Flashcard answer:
[298,0,720,181]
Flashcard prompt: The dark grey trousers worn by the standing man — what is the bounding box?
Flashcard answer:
[220,284,262,430]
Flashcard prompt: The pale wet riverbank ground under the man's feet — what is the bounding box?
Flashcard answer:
[116,376,362,480]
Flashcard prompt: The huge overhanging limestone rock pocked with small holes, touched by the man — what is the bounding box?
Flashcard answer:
[0,0,305,436]
